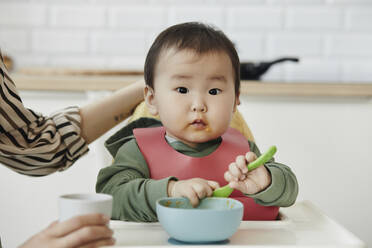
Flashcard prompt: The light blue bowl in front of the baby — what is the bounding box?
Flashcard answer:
[156,197,243,243]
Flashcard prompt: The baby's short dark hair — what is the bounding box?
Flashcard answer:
[144,22,240,95]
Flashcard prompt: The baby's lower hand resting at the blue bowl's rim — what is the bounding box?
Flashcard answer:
[168,178,220,207]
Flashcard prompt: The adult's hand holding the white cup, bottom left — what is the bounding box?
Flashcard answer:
[20,214,115,248]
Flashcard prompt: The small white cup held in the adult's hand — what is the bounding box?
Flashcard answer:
[58,193,112,221]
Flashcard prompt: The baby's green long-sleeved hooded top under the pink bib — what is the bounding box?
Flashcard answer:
[96,118,298,222]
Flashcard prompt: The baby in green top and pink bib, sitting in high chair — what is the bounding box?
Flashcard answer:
[96,22,298,222]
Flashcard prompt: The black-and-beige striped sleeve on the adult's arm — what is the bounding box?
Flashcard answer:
[0,51,88,176]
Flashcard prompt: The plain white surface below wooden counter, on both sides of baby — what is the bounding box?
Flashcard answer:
[0,92,372,248]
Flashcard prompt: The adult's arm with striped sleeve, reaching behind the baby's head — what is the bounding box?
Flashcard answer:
[0,51,142,176]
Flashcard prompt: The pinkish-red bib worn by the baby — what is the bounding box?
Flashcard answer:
[133,127,279,220]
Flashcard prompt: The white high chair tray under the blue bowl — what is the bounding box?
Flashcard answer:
[110,201,366,248]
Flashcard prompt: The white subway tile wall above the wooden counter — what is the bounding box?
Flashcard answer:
[0,0,372,82]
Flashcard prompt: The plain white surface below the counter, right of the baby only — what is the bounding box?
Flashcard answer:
[240,94,372,246]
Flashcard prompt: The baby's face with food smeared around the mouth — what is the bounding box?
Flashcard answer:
[146,49,238,146]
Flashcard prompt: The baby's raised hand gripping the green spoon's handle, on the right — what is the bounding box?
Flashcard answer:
[224,152,271,194]
